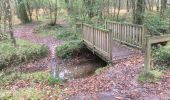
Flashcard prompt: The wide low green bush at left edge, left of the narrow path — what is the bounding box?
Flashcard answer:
[0,40,48,70]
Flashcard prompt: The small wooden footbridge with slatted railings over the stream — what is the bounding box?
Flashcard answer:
[82,21,145,62]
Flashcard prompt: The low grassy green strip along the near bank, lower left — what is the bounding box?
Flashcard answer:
[0,71,62,87]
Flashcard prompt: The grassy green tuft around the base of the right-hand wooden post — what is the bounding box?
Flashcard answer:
[138,70,163,83]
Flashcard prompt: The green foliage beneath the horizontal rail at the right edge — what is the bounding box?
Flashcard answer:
[154,43,170,64]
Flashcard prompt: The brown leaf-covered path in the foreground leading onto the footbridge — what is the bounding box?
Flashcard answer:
[65,55,170,100]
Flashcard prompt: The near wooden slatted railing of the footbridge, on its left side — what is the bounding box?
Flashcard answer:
[82,23,112,61]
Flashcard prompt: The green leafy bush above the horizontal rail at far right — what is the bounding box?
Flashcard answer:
[144,12,169,35]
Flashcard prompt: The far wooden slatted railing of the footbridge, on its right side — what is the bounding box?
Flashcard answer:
[106,21,145,49]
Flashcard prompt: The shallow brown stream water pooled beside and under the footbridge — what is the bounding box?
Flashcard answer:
[51,54,106,81]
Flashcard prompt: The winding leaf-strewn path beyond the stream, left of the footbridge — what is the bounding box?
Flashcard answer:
[14,24,63,72]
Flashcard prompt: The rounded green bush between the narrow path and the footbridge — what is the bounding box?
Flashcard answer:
[56,40,83,59]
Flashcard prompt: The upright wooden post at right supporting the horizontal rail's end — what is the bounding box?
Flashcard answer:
[144,36,151,73]
